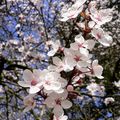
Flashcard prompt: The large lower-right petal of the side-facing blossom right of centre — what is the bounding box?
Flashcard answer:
[93,65,104,79]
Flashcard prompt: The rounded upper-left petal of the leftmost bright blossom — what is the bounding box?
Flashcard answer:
[23,69,34,81]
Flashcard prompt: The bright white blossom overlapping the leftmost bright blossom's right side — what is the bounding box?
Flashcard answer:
[41,70,67,93]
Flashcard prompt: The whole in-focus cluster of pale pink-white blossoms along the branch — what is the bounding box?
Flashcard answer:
[18,0,112,120]
